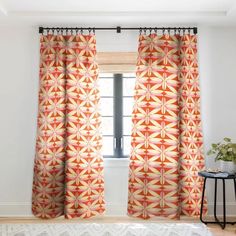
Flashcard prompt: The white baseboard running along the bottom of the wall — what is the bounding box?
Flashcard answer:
[0,202,236,217]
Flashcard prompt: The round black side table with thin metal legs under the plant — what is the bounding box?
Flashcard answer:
[198,171,236,229]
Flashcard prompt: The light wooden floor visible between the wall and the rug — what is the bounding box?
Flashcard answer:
[0,216,236,236]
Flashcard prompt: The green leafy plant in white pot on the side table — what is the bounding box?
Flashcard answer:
[207,138,236,174]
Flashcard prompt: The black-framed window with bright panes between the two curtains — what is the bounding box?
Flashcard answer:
[99,73,135,158]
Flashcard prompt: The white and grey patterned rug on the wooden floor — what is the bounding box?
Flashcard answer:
[0,223,212,236]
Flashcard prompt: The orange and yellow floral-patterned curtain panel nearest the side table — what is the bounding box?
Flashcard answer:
[128,34,206,219]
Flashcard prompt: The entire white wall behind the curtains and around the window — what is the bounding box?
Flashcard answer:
[0,27,236,216]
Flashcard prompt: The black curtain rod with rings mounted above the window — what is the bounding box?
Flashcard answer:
[39,26,197,34]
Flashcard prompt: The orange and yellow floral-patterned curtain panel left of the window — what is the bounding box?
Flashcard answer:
[32,34,104,218]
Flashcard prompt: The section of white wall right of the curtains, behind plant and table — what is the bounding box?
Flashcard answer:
[199,27,236,215]
